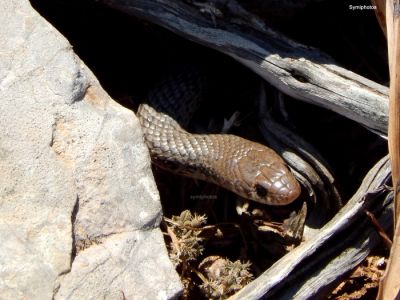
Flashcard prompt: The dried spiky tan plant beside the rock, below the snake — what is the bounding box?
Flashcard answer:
[164,210,253,299]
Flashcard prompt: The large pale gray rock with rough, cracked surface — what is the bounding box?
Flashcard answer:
[0,0,181,299]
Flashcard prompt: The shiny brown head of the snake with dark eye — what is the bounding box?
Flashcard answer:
[236,144,301,205]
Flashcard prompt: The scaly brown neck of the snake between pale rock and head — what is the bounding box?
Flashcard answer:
[137,104,233,184]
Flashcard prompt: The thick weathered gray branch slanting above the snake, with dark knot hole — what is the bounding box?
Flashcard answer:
[102,0,388,135]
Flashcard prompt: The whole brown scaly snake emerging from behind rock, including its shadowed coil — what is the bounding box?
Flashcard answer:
[137,70,301,205]
